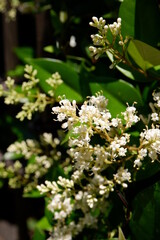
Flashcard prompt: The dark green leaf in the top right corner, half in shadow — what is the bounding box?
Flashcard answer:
[119,0,160,47]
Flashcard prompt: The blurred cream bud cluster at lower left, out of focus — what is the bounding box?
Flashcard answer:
[0,133,61,192]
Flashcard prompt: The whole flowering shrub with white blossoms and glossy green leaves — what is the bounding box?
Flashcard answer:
[0,0,160,240]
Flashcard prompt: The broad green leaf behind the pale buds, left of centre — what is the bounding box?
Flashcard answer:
[28,58,82,102]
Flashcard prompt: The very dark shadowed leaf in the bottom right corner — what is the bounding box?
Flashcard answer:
[130,183,160,240]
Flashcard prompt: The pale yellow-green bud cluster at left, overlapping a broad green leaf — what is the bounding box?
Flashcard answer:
[0,65,62,121]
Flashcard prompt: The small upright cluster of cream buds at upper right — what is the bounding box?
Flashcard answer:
[89,17,128,66]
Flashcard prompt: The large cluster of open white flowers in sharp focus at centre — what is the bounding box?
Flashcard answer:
[38,90,160,240]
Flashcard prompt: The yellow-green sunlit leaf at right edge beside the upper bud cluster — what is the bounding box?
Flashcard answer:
[127,40,160,71]
